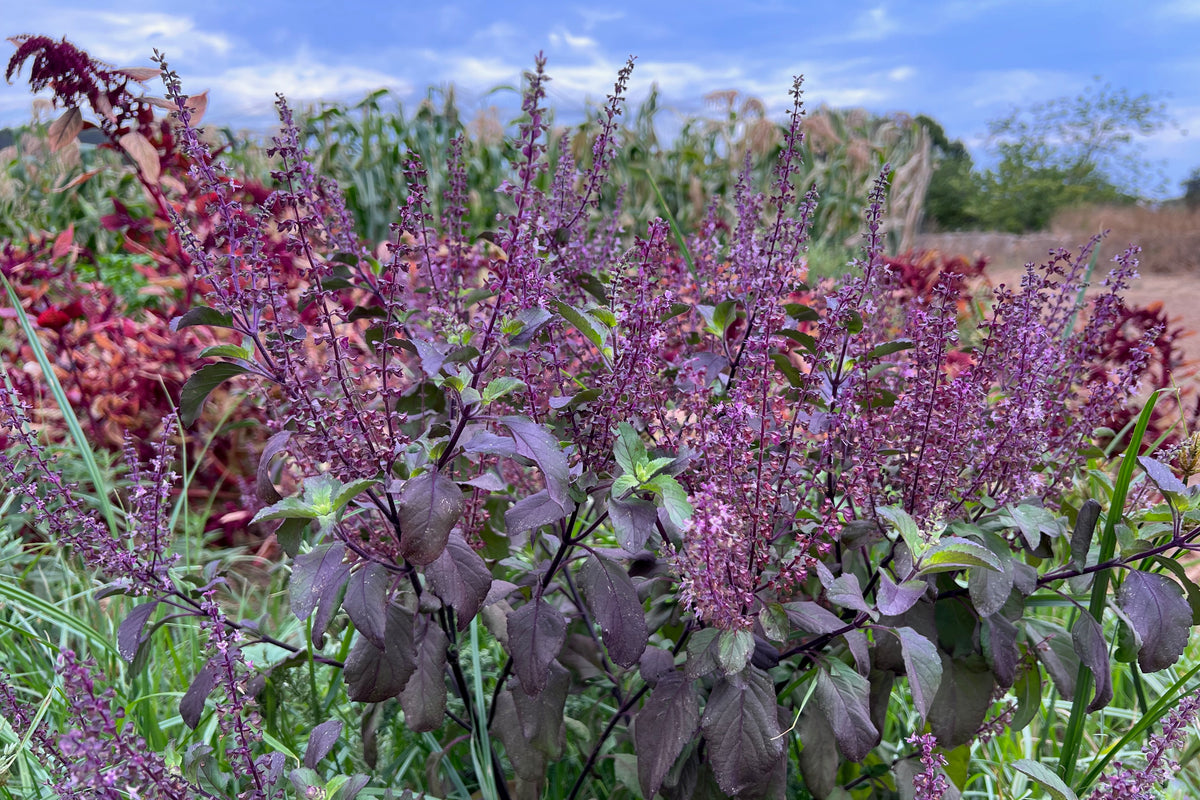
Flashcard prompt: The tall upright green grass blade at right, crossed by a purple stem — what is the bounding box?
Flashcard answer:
[1058,392,1158,786]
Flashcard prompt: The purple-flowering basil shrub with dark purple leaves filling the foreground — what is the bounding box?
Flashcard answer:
[0,34,1198,800]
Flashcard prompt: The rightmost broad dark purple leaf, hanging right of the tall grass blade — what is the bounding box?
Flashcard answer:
[1117,570,1192,672]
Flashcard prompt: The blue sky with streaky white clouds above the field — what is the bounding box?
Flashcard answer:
[0,0,1200,194]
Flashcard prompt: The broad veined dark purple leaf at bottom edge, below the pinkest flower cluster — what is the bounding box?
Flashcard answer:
[700,669,784,795]
